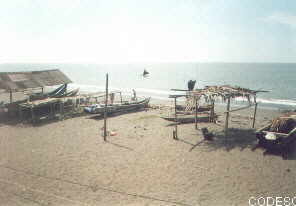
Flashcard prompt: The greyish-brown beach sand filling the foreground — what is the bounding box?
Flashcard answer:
[0,103,296,206]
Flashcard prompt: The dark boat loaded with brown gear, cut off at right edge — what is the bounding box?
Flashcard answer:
[256,113,296,150]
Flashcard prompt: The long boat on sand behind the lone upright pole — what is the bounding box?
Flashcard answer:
[84,97,150,114]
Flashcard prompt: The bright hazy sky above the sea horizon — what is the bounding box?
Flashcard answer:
[0,0,296,63]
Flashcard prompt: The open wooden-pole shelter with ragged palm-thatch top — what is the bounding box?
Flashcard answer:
[169,85,268,139]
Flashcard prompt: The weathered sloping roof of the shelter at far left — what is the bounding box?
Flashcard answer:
[0,69,72,91]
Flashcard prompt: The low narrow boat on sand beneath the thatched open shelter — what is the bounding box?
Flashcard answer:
[160,113,217,123]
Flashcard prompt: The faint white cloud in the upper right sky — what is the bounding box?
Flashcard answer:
[265,12,296,27]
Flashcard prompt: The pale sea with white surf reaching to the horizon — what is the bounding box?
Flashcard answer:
[0,63,296,109]
